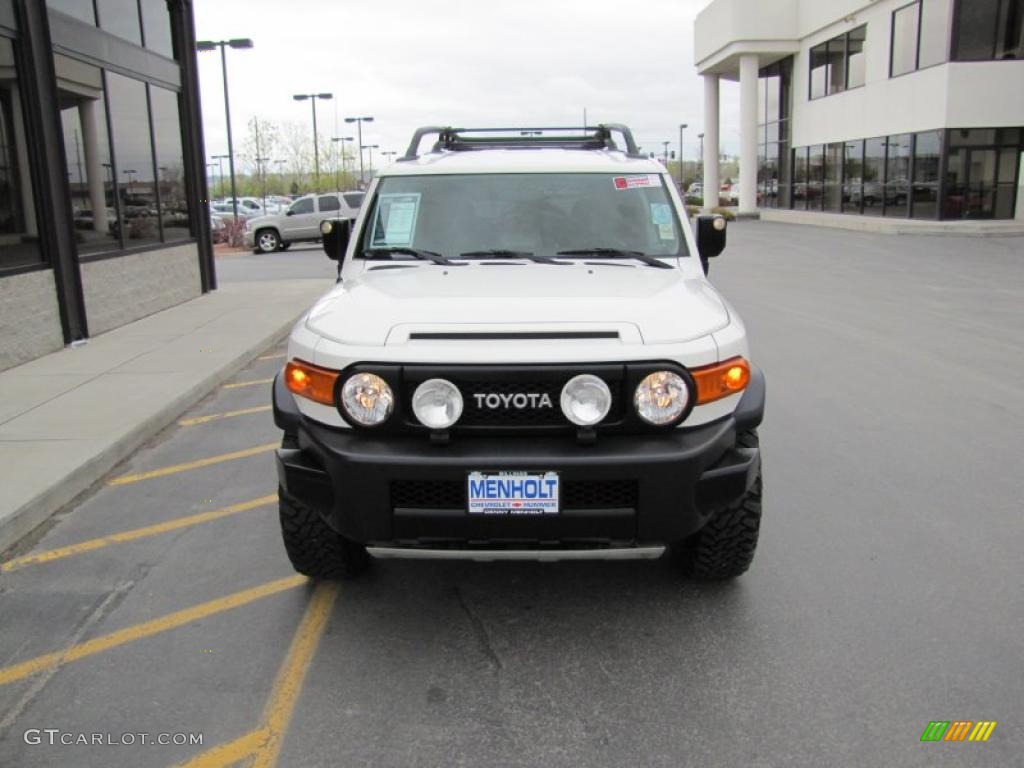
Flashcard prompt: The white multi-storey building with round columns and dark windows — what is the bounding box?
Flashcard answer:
[695,0,1024,230]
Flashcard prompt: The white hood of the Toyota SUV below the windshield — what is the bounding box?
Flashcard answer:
[305,261,729,346]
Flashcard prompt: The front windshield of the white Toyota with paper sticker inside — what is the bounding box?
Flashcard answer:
[362,173,688,258]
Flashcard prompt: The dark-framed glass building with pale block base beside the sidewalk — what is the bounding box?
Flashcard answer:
[0,0,214,370]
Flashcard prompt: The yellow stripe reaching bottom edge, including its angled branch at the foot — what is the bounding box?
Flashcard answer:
[179,582,338,768]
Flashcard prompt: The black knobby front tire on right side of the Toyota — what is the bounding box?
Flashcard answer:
[674,429,761,582]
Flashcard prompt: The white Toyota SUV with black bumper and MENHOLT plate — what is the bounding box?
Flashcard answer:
[273,125,765,579]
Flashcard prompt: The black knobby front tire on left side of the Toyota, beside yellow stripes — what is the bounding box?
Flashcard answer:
[278,486,370,580]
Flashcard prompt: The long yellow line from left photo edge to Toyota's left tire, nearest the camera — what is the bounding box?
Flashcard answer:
[0,575,308,685]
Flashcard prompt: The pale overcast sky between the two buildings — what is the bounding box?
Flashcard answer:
[195,0,738,168]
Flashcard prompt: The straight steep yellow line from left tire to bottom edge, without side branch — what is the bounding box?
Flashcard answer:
[252,582,338,768]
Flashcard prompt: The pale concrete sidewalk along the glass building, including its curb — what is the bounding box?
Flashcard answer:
[0,280,331,552]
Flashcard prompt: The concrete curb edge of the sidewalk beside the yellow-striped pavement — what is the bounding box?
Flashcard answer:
[0,310,296,553]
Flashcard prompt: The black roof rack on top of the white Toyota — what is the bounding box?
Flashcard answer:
[398,123,643,162]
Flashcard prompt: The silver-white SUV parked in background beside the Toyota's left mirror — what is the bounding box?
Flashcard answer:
[245,191,362,253]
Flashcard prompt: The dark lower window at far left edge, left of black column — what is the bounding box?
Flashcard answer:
[0,37,43,273]
